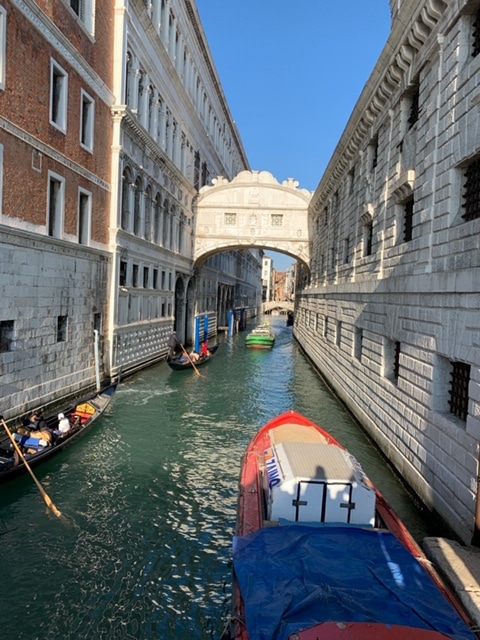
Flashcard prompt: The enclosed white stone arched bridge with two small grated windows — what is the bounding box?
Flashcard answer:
[194,171,313,267]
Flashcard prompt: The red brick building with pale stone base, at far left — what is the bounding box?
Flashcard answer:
[0,0,114,417]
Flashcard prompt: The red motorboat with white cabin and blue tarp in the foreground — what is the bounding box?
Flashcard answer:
[227,411,478,640]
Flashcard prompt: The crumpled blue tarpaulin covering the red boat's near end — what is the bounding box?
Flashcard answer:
[233,525,475,640]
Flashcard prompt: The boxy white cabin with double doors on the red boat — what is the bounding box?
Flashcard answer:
[264,441,375,526]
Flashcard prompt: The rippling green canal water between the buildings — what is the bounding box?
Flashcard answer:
[0,316,435,640]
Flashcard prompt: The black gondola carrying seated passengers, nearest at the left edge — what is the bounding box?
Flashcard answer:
[0,381,118,482]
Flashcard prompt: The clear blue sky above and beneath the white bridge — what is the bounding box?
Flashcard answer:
[196,0,390,270]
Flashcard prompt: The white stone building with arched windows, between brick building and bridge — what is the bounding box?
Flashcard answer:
[108,0,260,374]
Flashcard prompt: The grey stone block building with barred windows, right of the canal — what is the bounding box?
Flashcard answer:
[294,0,480,542]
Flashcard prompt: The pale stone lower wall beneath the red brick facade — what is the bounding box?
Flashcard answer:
[0,230,110,418]
